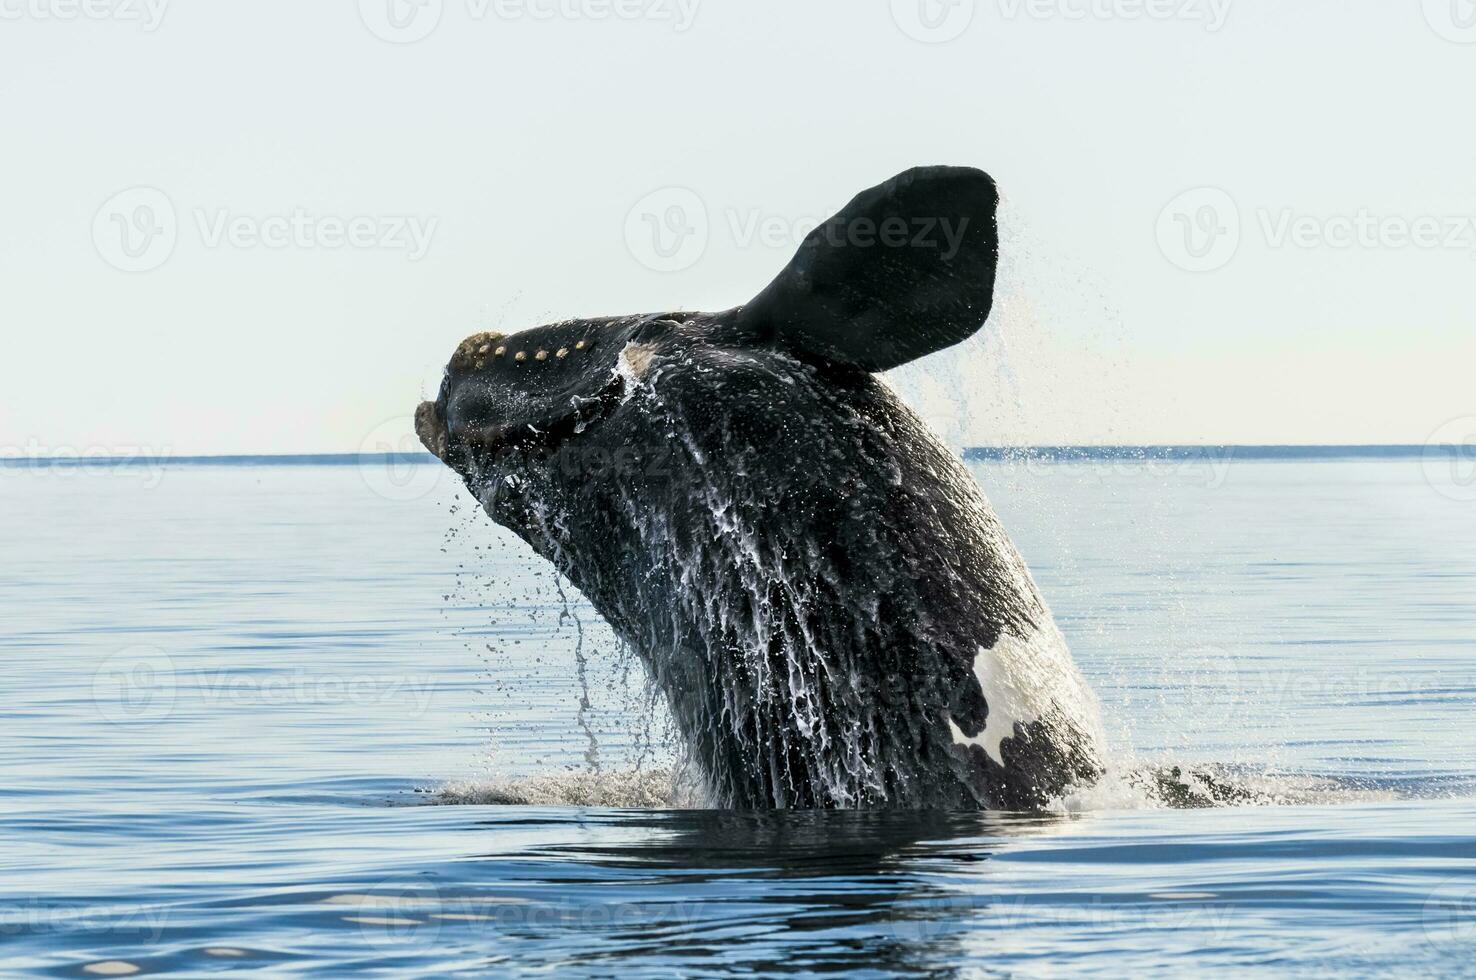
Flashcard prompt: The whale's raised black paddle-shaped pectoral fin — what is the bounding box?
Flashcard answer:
[737,167,999,370]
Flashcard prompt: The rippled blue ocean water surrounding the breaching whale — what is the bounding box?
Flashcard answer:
[0,455,1476,977]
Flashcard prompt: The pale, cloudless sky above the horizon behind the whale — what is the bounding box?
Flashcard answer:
[0,0,1476,455]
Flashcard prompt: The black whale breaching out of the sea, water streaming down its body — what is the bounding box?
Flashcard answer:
[416,167,1101,809]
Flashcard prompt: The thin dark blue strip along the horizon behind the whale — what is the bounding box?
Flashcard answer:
[0,444,1476,469]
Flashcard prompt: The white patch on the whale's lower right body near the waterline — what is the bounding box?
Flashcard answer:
[948,624,1103,766]
